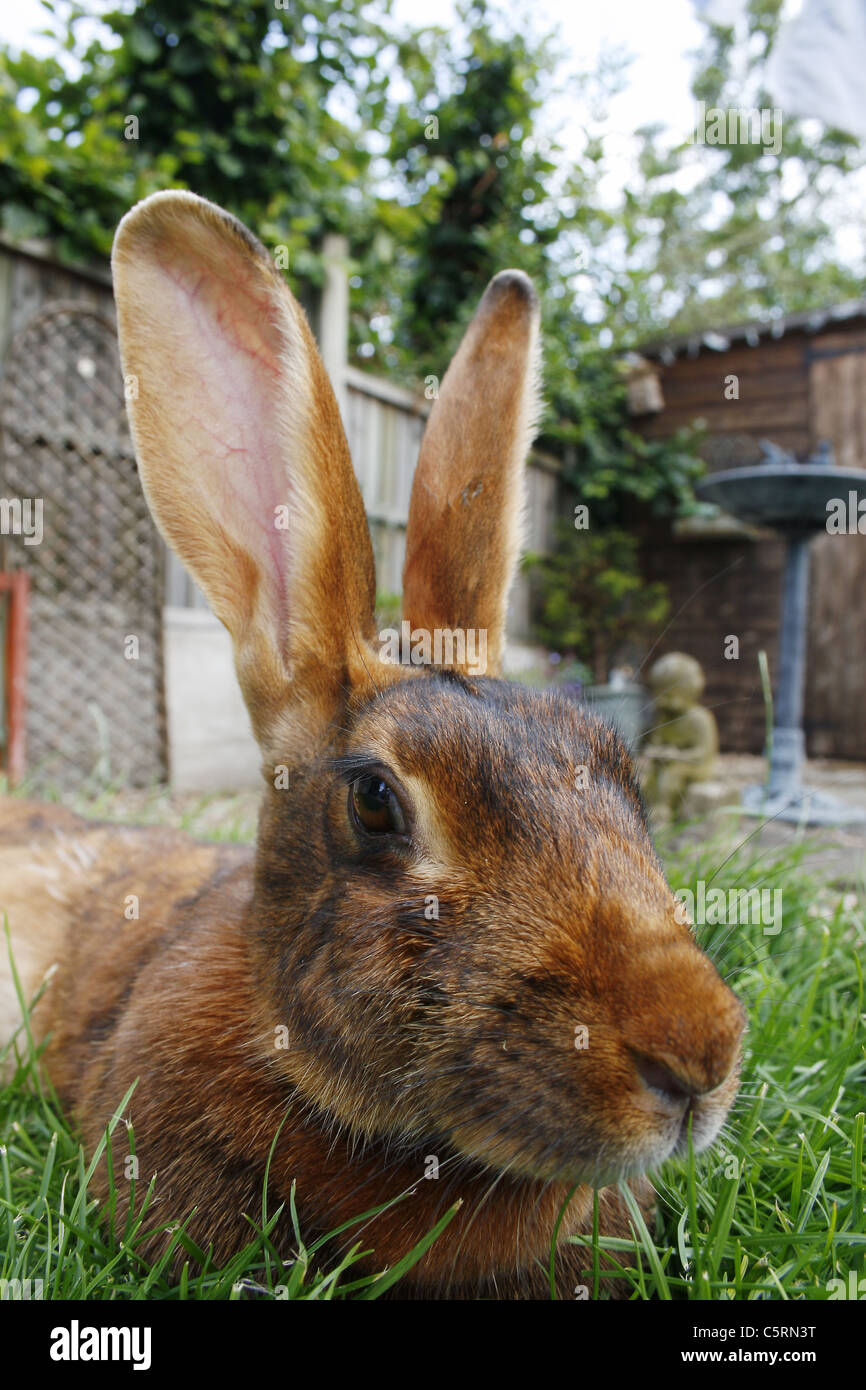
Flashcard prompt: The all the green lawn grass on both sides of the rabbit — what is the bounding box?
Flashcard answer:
[0,806,866,1300]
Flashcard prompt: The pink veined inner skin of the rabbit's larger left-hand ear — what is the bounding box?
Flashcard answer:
[151,240,292,630]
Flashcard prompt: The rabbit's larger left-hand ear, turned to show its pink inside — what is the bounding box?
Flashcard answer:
[113,192,375,742]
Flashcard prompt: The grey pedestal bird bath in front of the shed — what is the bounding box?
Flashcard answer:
[695,441,866,826]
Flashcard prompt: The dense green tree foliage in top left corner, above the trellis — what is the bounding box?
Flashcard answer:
[0,0,386,277]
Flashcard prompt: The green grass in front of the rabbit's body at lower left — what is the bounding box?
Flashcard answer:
[0,923,460,1301]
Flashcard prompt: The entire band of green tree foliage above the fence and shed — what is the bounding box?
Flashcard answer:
[0,0,860,525]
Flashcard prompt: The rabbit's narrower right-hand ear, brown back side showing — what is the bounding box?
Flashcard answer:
[403,270,539,674]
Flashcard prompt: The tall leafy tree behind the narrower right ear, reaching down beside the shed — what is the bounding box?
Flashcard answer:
[353,0,701,521]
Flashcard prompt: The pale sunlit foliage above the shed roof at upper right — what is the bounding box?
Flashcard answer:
[610,0,866,338]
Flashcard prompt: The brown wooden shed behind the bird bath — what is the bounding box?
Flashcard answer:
[639,300,866,759]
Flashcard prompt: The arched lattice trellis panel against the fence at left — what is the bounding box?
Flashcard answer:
[0,302,165,787]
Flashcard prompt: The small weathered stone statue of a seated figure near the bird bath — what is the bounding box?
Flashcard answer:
[641,652,719,824]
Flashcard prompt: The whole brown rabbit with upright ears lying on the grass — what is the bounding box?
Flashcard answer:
[0,192,744,1297]
